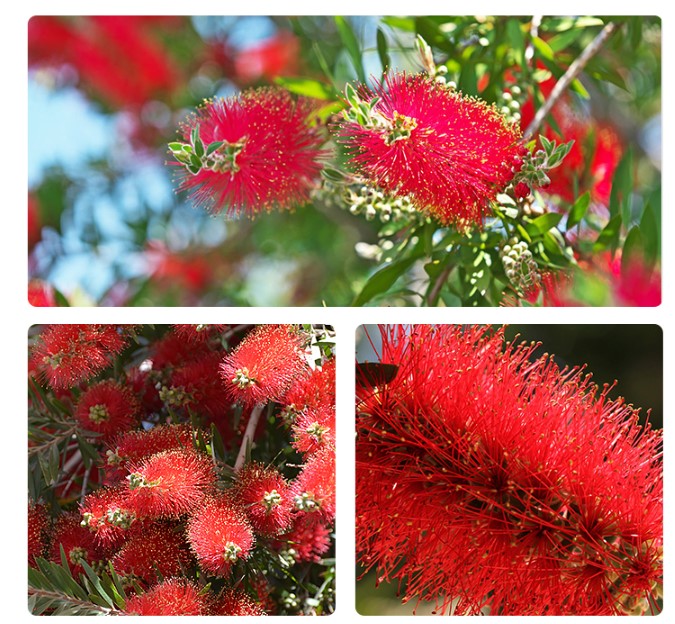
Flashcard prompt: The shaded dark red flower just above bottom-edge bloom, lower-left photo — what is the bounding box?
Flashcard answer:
[112,523,191,583]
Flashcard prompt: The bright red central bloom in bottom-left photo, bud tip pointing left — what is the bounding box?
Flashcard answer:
[127,449,216,518]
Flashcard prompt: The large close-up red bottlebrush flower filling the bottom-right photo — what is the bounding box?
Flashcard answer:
[356,325,663,615]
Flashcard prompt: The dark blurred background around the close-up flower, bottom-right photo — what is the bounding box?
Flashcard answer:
[356,324,664,615]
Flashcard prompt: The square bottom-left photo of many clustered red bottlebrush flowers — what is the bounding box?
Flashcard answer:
[27,324,336,616]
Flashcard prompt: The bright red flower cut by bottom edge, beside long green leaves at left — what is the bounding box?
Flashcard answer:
[124,578,207,615]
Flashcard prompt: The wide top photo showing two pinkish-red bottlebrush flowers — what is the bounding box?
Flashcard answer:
[27,15,662,307]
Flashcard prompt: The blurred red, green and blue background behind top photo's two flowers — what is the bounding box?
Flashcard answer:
[28,16,661,306]
